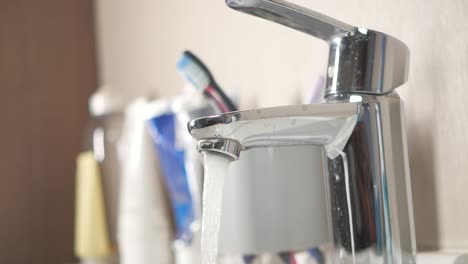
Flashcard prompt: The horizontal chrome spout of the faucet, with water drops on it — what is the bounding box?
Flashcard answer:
[188,103,360,160]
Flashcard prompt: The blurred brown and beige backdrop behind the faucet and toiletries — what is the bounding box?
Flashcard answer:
[0,0,468,263]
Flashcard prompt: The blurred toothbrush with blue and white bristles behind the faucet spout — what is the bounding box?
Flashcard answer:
[177,51,237,112]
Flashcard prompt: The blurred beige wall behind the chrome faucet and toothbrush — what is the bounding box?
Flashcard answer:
[96,0,468,249]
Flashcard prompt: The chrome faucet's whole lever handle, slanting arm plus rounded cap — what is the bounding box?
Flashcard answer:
[226,0,409,96]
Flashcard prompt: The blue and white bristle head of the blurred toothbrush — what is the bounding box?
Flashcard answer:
[177,54,210,90]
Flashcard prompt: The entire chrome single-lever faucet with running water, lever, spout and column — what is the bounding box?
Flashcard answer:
[188,0,416,264]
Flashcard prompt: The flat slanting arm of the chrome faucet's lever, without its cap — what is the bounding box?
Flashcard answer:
[226,0,356,41]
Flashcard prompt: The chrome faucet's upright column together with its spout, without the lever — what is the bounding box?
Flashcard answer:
[189,93,416,264]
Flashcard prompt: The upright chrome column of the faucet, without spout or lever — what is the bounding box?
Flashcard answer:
[325,93,416,263]
